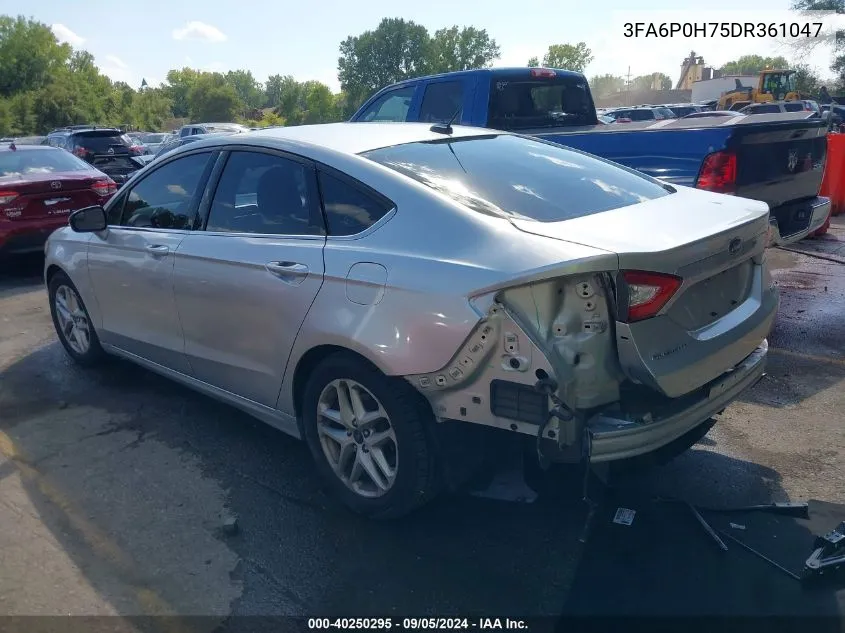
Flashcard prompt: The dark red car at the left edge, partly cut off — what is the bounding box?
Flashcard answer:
[0,143,117,255]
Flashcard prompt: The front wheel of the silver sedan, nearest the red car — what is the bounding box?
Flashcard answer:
[47,272,106,367]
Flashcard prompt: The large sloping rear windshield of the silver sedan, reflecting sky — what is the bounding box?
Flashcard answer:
[363,135,671,222]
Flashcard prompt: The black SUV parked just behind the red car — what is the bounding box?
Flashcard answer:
[44,126,145,186]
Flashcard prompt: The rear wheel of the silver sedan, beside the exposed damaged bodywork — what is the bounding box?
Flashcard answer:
[302,353,440,519]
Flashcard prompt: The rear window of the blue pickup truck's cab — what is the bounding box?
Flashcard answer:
[488,77,596,130]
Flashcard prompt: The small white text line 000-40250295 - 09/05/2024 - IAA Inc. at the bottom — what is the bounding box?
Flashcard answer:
[308,618,528,631]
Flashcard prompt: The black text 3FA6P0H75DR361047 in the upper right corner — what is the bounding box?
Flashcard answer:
[623,22,823,38]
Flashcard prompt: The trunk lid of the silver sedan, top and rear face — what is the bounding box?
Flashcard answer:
[512,188,771,397]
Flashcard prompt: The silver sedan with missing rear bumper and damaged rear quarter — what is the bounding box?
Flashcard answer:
[45,123,778,517]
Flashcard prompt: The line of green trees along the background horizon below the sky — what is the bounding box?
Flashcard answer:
[0,8,832,136]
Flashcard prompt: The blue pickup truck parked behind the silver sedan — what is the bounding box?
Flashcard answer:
[351,68,830,245]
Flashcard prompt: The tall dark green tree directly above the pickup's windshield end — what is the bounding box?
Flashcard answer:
[337,18,432,110]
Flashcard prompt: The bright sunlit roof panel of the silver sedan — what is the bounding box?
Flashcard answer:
[241,122,507,154]
